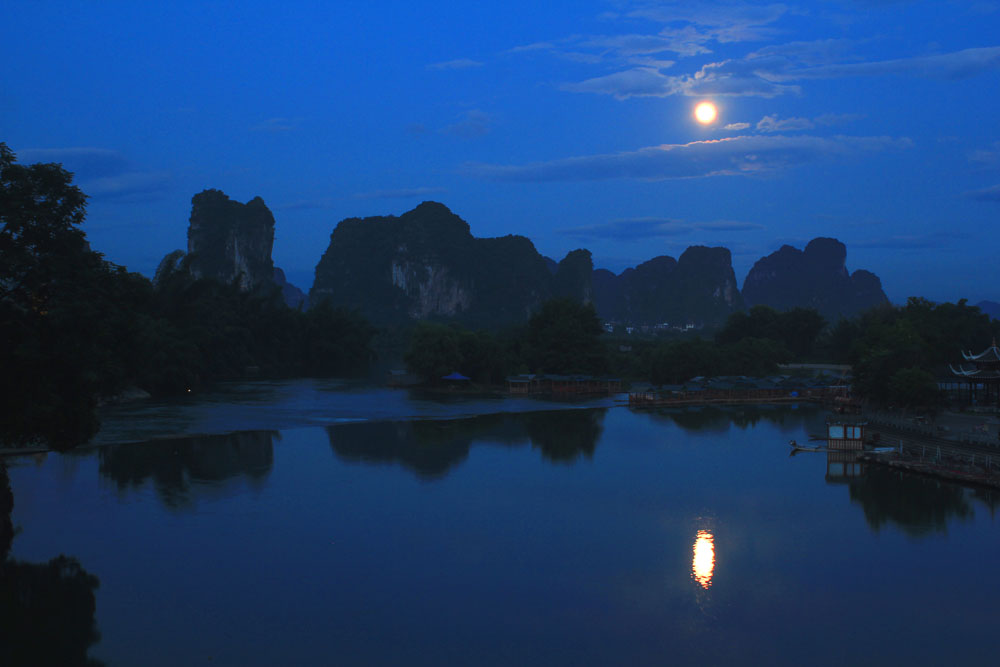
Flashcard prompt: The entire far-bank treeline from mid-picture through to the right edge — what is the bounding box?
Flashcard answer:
[405,297,1000,407]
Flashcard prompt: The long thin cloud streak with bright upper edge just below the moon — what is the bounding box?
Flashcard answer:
[465,135,912,182]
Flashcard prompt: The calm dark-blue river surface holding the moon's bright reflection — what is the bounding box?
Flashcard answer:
[1,389,1000,665]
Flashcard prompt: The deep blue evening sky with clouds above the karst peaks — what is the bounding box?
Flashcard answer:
[0,0,1000,302]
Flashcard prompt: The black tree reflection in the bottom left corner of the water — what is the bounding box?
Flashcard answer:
[0,462,101,667]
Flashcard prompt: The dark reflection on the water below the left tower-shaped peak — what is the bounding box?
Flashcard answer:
[99,431,279,509]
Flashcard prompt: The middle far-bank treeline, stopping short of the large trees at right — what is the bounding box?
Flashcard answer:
[405,299,812,384]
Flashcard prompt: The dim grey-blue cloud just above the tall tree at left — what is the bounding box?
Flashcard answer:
[17,147,173,201]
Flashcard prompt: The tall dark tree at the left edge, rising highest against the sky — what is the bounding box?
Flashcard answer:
[0,143,119,447]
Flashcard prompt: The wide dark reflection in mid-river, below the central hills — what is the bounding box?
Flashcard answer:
[326,409,605,479]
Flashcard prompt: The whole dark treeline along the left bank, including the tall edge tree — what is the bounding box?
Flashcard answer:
[0,143,374,448]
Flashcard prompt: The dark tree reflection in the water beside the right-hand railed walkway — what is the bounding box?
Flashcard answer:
[850,466,972,537]
